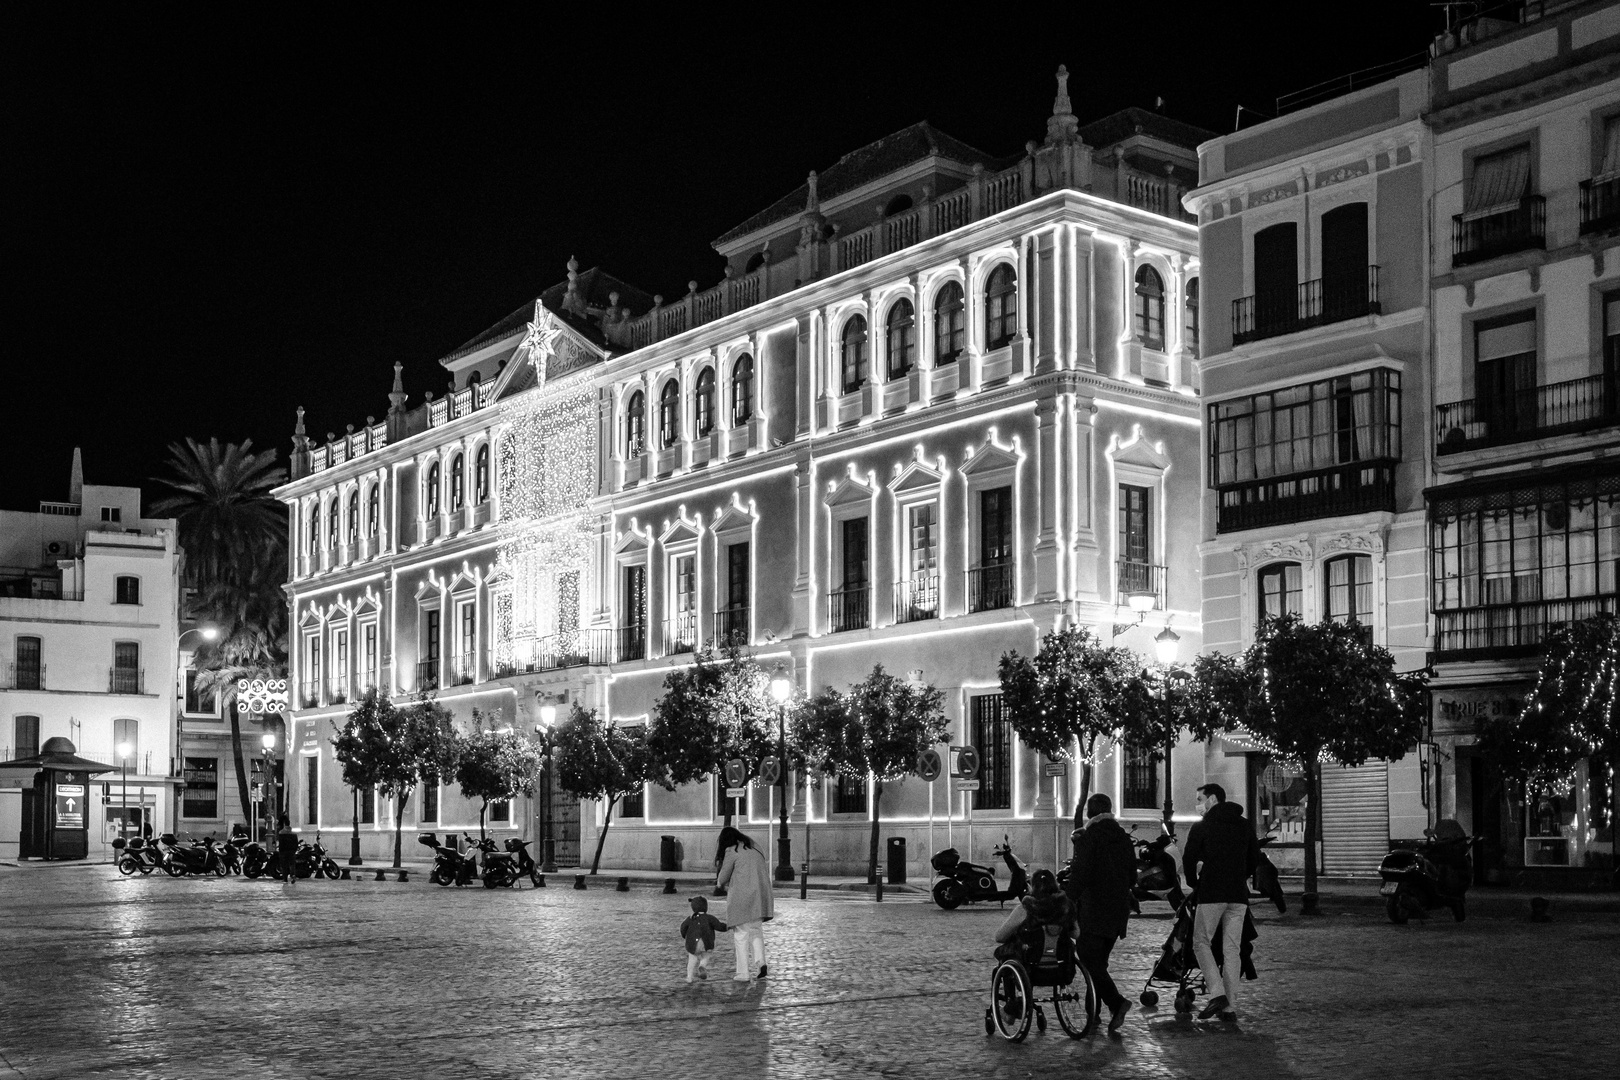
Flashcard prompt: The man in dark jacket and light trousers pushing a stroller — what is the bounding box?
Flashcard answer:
[1181,784,1260,1020]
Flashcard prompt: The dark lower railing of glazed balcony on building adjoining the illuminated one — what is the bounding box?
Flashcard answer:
[1215,458,1396,533]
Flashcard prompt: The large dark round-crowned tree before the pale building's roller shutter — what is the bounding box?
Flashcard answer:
[1209,615,1427,894]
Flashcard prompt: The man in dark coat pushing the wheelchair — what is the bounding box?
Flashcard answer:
[1064,792,1136,1031]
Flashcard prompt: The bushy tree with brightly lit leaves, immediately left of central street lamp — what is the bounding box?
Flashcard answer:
[646,646,776,824]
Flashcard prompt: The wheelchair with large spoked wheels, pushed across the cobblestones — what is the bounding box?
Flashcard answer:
[985,923,1102,1043]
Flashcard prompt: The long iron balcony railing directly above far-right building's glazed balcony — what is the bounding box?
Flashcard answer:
[1434,363,1620,453]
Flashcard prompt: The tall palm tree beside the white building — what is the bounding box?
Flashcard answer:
[151,439,287,818]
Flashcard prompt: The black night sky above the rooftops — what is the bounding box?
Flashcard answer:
[0,0,1437,508]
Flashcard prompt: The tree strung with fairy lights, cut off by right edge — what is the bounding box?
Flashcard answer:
[1477,615,1620,839]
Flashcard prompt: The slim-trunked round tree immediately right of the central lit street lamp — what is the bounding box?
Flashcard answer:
[794,664,951,884]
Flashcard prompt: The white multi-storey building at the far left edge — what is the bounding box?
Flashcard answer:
[0,452,181,858]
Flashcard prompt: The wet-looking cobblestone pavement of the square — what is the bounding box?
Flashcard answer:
[0,868,1620,1080]
